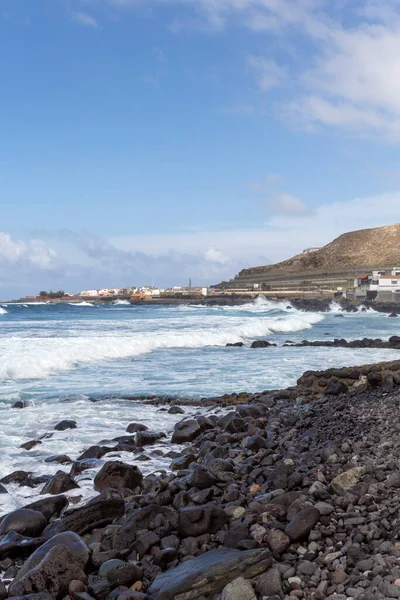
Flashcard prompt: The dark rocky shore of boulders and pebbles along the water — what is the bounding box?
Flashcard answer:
[0,361,400,600]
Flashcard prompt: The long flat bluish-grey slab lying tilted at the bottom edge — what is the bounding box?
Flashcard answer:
[148,548,272,600]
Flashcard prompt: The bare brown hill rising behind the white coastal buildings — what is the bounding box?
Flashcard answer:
[239,223,400,276]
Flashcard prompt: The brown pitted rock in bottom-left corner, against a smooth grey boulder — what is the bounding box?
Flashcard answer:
[9,545,86,597]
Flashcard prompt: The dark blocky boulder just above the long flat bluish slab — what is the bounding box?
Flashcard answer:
[179,504,228,537]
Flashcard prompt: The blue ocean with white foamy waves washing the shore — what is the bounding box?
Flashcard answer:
[0,297,399,514]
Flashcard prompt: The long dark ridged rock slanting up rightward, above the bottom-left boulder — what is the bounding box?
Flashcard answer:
[43,494,125,539]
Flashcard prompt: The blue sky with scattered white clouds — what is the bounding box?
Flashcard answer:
[0,0,400,299]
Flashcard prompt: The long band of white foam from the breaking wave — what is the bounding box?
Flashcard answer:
[0,313,324,381]
